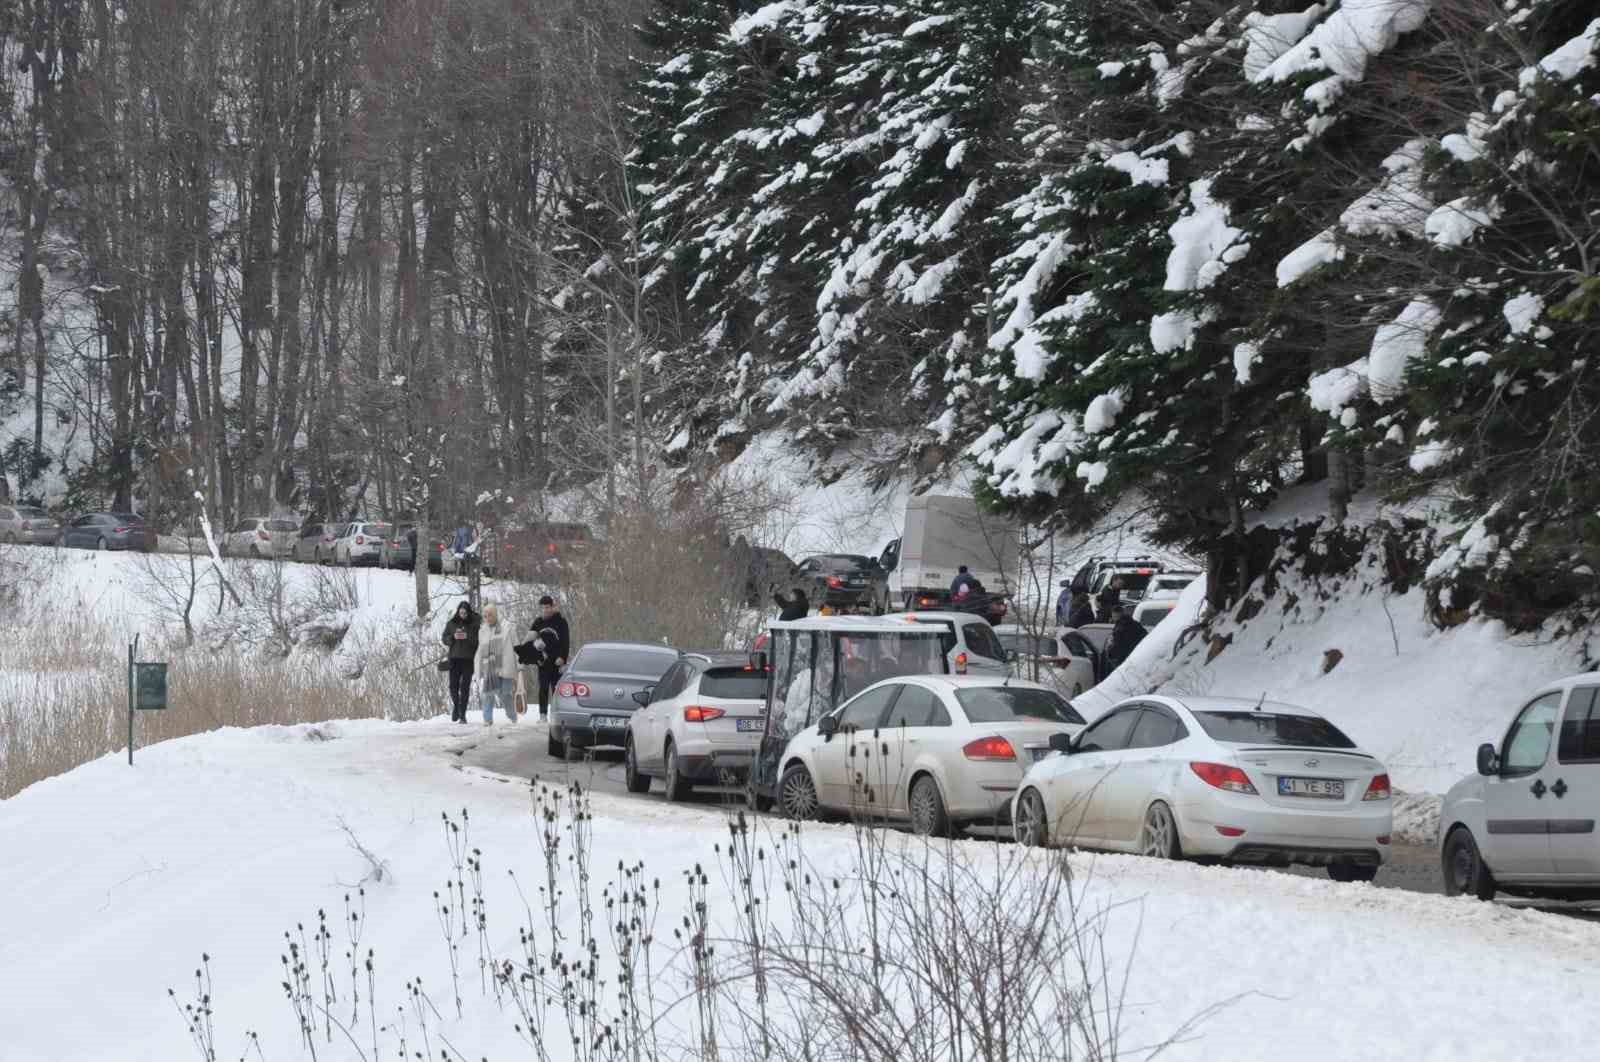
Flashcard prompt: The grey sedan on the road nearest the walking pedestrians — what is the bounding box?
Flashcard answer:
[549,641,678,758]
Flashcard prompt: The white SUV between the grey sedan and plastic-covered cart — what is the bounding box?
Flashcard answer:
[624,653,766,800]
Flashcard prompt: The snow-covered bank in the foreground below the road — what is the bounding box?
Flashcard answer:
[0,721,1600,1062]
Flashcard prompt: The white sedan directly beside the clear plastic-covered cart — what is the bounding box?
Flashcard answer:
[778,675,1083,835]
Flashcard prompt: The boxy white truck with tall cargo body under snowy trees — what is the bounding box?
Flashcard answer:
[877,494,1022,613]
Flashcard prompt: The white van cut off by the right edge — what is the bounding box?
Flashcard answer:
[1438,672,1600,900]
